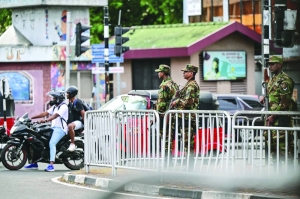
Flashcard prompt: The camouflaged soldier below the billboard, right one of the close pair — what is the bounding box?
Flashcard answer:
[170,64,200,152]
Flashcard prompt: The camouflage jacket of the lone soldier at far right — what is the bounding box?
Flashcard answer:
[268,72,294,126]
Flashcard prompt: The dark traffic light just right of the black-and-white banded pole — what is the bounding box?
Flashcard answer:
[114,26,130,57]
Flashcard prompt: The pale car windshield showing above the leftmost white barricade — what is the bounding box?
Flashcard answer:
[99,95,147,112]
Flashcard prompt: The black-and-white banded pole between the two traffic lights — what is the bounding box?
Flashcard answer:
[104,6,109,101]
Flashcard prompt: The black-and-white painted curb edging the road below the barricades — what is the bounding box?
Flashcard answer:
[62,173,287,199]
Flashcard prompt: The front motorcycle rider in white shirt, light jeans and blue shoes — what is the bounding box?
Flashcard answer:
[25,90,68,171]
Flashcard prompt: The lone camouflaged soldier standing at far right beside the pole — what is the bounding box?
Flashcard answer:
[260,56,294,162]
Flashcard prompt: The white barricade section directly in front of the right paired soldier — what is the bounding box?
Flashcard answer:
[162,110,232,173]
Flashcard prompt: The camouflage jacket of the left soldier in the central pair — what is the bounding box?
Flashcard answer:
[156,77,178,113]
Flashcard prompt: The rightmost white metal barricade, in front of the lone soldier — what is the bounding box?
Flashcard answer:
[232,111,300,174]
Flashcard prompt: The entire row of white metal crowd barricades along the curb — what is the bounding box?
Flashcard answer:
[84,110,300,175]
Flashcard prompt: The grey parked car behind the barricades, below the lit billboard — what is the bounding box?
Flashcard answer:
[216,94,264,141]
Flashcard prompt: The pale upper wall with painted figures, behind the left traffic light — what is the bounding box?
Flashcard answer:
[12,7,90,46]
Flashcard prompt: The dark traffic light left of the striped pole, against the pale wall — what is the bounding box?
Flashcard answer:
[75,22,91,57]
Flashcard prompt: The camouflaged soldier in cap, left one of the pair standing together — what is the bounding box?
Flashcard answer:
[155,64,178,151]
